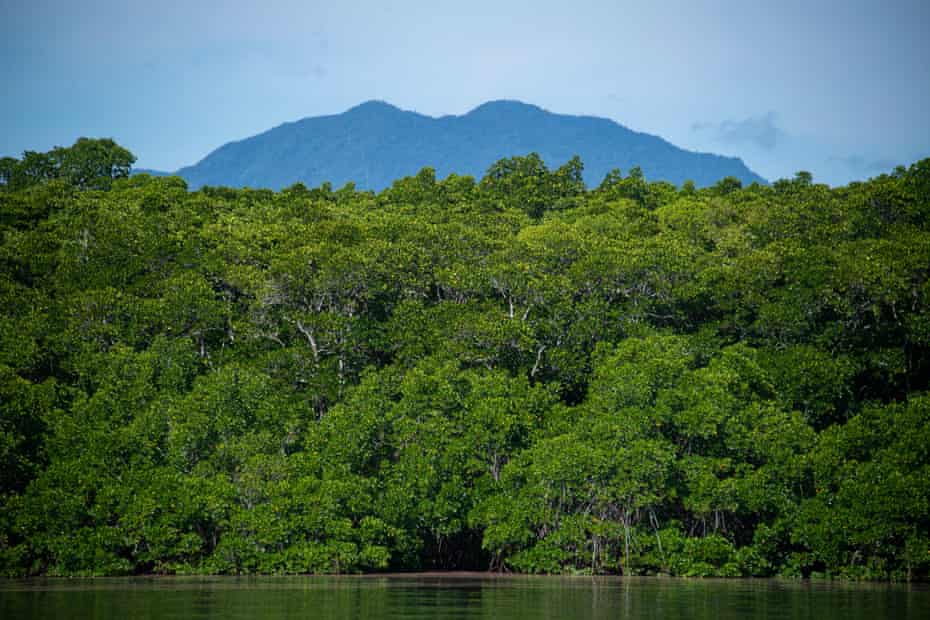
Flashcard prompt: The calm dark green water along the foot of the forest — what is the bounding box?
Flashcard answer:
[0,574,930,620]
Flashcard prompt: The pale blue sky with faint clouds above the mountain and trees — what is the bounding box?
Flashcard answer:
[0,0,930,185]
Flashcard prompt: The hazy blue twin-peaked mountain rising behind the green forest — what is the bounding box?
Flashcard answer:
[161,101,765,190]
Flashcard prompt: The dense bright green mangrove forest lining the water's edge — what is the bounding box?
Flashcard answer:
[0,142,930,579]
